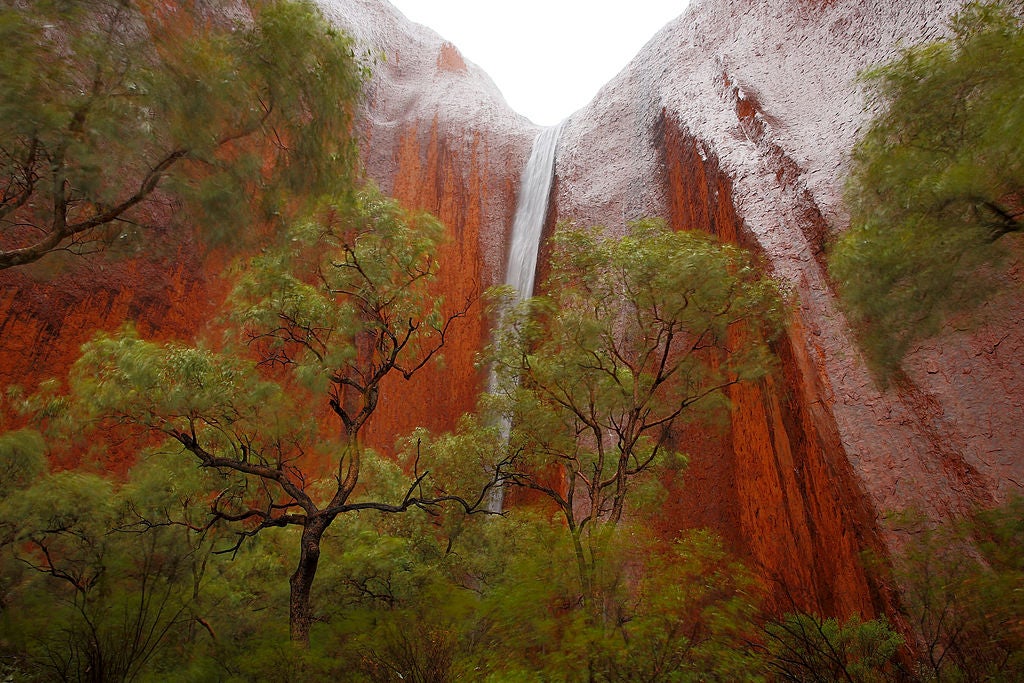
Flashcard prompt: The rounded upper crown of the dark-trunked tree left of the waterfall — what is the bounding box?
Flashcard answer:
[231,185,461,401]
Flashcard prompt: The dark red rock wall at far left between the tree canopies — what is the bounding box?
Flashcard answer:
[0,229,234,473]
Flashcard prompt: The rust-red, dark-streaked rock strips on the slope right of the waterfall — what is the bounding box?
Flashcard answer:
[660,115,888,617]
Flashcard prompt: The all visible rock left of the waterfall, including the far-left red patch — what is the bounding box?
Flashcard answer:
[0,0,538,464]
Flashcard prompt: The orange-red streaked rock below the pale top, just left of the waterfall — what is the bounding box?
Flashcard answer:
[358,118,518,449]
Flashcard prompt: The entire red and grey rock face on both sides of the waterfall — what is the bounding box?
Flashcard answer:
[0,0,1024,616]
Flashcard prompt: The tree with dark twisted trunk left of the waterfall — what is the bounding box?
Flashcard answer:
[71,187,486,643]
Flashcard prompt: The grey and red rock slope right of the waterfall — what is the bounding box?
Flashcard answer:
[554,0,1024,615]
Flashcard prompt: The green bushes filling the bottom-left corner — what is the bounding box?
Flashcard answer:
[0,454,226,681]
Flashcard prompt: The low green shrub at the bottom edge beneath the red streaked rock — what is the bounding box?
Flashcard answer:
[764,613,903,683]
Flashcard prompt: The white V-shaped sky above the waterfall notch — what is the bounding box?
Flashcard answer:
[390,0,689,126]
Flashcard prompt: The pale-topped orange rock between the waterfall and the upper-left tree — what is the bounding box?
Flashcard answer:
[323,0,538,449]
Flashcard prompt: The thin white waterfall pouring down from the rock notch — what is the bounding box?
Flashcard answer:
[487,121,565,512]
